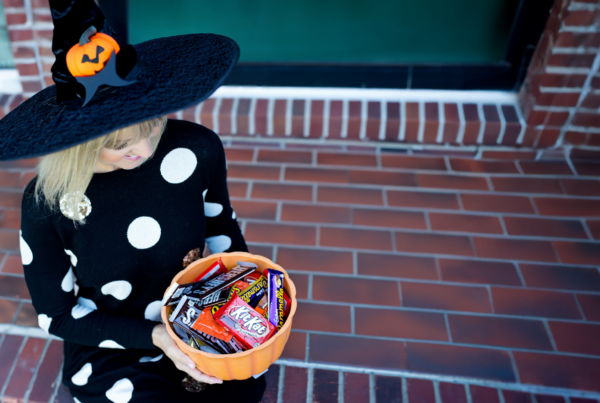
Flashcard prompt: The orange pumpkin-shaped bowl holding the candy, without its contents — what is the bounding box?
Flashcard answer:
[160,252,298,381]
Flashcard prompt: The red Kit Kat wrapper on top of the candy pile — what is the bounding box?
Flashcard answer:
[214,294,276,349]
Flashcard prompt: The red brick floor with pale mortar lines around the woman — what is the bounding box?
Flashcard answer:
[0,133,600,403]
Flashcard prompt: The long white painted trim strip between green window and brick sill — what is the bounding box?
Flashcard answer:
[213,85,518,104]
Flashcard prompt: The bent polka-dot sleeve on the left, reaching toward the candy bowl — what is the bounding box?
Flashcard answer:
[20,186,157,349]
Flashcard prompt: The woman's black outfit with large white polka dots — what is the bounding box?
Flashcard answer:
[21,120,261,403]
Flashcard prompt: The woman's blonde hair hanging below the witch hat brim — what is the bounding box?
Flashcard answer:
[34,116,167,224]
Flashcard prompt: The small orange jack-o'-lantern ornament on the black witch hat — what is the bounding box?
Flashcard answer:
[67,26,121,77]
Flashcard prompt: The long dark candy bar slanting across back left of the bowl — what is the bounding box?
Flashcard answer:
[167,262,257,305]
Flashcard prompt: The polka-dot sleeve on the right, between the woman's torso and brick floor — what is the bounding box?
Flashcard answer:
[202,134,248,253]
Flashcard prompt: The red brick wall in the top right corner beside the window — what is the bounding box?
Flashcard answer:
[520,0,600,147]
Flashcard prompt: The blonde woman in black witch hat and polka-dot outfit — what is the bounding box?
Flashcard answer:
[0,0,265,403]
